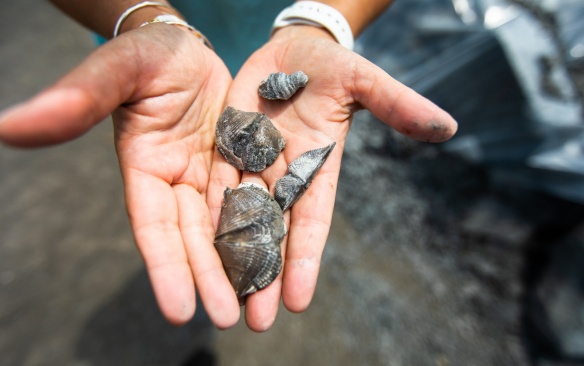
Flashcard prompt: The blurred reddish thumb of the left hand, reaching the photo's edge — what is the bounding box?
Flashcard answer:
[0,37,137,147]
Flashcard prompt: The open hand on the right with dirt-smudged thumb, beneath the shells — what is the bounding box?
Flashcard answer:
[207,26,457,331]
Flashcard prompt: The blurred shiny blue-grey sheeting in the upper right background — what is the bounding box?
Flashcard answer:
[358,0,584,203]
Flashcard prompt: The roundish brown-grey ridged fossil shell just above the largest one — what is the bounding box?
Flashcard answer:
[215,107,286,172]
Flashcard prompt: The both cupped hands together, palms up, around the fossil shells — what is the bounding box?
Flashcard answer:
[0,24,456,331]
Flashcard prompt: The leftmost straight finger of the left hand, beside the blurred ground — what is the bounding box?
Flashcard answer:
[123,170,196,325]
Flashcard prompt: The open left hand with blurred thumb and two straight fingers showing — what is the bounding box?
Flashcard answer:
[0,24,239,328]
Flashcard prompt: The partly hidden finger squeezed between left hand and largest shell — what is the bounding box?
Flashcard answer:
[207,149,241,229]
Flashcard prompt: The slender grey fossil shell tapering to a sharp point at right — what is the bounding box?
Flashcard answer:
[275,142,336,211]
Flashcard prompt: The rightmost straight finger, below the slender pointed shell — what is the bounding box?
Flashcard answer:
[282,149,343,312]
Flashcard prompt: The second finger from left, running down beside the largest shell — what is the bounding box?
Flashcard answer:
[173,184,239,329]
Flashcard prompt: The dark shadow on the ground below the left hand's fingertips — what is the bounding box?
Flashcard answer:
[76,271,216,366]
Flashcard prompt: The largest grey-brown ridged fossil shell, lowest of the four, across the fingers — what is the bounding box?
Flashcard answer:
[215,183,286,303]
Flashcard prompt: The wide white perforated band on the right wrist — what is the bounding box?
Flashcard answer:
[272,1,355,50]
